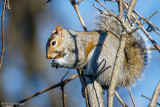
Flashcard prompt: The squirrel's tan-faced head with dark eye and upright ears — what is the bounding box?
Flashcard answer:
[46,25,66,59]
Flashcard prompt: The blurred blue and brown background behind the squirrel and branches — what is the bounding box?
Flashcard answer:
[0,0,160,107]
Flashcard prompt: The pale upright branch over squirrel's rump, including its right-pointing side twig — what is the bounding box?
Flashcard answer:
[96,0,160,107]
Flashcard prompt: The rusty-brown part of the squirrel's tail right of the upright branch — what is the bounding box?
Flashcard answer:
[123,33,148,86]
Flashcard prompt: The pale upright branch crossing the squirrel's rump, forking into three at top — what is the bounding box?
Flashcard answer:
[96,0,139,107]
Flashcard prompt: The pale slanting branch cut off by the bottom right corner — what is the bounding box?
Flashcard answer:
[149,81,160,107]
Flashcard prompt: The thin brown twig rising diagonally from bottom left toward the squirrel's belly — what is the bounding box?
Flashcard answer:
[14,74,78,107]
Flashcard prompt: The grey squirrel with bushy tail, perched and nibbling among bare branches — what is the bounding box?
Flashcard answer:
[46,15,148,89]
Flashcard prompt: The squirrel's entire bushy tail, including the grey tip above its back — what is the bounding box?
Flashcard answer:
[96,15,148,86]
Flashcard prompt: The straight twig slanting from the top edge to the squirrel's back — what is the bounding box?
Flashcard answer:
[70,0,87,31]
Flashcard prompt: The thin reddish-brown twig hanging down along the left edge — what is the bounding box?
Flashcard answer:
[0,0,7,71]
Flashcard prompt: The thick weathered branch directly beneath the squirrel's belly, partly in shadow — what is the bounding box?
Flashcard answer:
[77,69,104,107]
